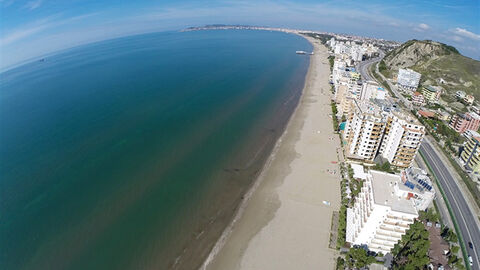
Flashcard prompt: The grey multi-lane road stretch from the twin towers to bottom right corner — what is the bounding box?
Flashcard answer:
[420,139,480,269]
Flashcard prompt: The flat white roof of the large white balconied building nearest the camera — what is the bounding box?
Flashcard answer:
[370,171,418,215]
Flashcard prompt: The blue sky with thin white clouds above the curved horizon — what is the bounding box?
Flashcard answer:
[0,0,480,68]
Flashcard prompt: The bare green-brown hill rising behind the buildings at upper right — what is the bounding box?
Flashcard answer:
[379,40,480,100]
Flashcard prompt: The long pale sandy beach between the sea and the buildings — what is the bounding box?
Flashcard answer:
[202,36,340,269]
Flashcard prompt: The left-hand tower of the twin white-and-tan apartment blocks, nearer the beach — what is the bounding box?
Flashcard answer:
[344,99,386,162]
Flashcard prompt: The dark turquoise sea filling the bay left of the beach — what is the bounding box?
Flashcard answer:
[0,31,311,269]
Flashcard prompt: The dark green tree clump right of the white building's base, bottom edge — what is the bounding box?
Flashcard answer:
[392,221,430,269]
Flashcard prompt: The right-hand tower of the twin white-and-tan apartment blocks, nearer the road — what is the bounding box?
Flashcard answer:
[379,112,425,168]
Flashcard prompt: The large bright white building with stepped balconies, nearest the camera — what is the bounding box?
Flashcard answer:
[346,171,429,254]
